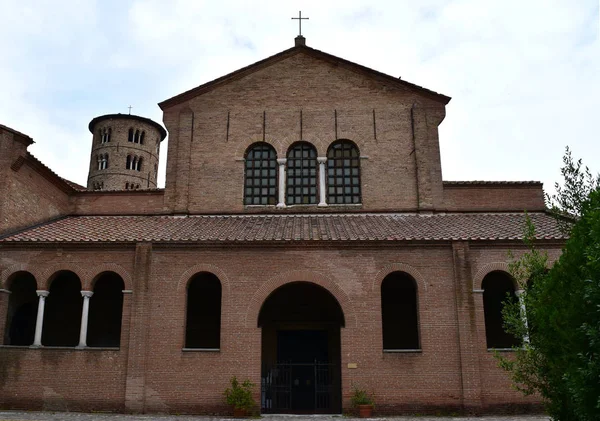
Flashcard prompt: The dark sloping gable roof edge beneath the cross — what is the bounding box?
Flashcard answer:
[158,41,451,110]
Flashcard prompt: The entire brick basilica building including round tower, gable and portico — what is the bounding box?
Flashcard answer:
[0,37,565,414]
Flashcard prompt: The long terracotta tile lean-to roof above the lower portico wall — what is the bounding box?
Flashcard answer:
[0,213,564,243]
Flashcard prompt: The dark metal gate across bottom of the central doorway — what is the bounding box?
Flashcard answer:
[261,361,334,414]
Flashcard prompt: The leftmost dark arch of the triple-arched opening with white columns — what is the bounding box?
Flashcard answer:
[4,272,38,346]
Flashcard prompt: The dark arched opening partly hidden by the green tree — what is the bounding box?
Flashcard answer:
[481,270,521,348]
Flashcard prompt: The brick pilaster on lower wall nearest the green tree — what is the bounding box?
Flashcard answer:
[452,241,482,413]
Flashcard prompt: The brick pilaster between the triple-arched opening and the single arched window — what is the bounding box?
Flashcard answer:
[125,243,152,412]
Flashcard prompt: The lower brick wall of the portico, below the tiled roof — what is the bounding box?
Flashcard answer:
[0,243,559,413]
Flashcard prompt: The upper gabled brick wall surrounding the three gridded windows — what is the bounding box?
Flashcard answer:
[164,53,444,213]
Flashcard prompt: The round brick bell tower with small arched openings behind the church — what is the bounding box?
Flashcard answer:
[87,114,167,190]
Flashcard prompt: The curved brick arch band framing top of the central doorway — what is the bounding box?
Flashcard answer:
[245,270,356,328]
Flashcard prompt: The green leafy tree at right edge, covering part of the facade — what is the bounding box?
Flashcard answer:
[498,149,600,421]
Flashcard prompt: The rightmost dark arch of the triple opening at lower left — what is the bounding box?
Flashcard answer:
[87,272,125,347]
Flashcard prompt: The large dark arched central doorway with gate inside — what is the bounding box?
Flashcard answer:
[258,282,345,413]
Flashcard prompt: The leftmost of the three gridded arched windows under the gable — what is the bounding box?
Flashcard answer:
[244,143,277,205]
